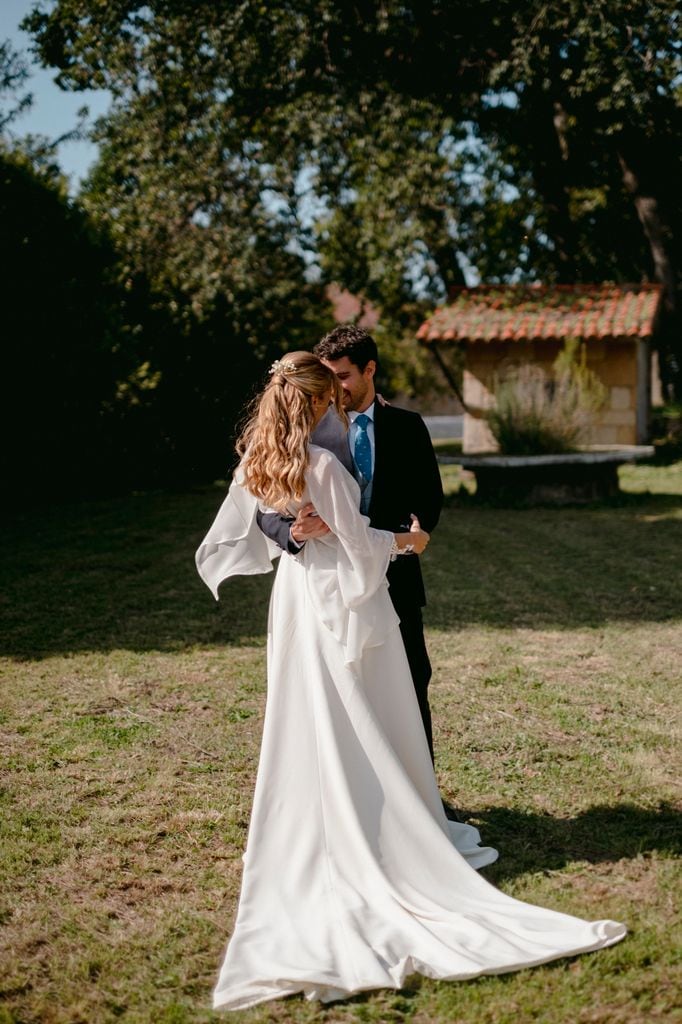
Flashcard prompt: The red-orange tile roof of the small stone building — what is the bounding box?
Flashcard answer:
[417,285,662,343]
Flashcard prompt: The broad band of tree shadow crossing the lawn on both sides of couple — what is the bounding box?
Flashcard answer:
[0,487,682,658]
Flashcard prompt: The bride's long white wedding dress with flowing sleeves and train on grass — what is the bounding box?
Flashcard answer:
[197,445,626,1010]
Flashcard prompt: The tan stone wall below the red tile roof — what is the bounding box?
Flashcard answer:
[463,339,648,453]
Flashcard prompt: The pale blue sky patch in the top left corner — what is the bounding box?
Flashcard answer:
[0,0,110,190]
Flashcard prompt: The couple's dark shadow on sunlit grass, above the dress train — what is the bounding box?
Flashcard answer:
[465,803,682,882]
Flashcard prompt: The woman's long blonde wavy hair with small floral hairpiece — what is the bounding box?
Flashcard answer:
[237,352,348,512]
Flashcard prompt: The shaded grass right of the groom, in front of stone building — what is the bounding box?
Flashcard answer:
[424,494,682,631]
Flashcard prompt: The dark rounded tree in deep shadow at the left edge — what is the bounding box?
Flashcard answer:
[0,142,127,498]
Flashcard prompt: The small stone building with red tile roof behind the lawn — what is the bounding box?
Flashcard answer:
[418,285,662,453]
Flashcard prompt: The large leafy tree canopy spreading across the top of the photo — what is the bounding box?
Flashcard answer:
[23,0,682,395]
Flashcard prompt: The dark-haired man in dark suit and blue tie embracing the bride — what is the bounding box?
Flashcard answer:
[258,325,442,760]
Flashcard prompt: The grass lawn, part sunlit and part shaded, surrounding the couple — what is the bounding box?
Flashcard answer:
[0,463,682,1024]
